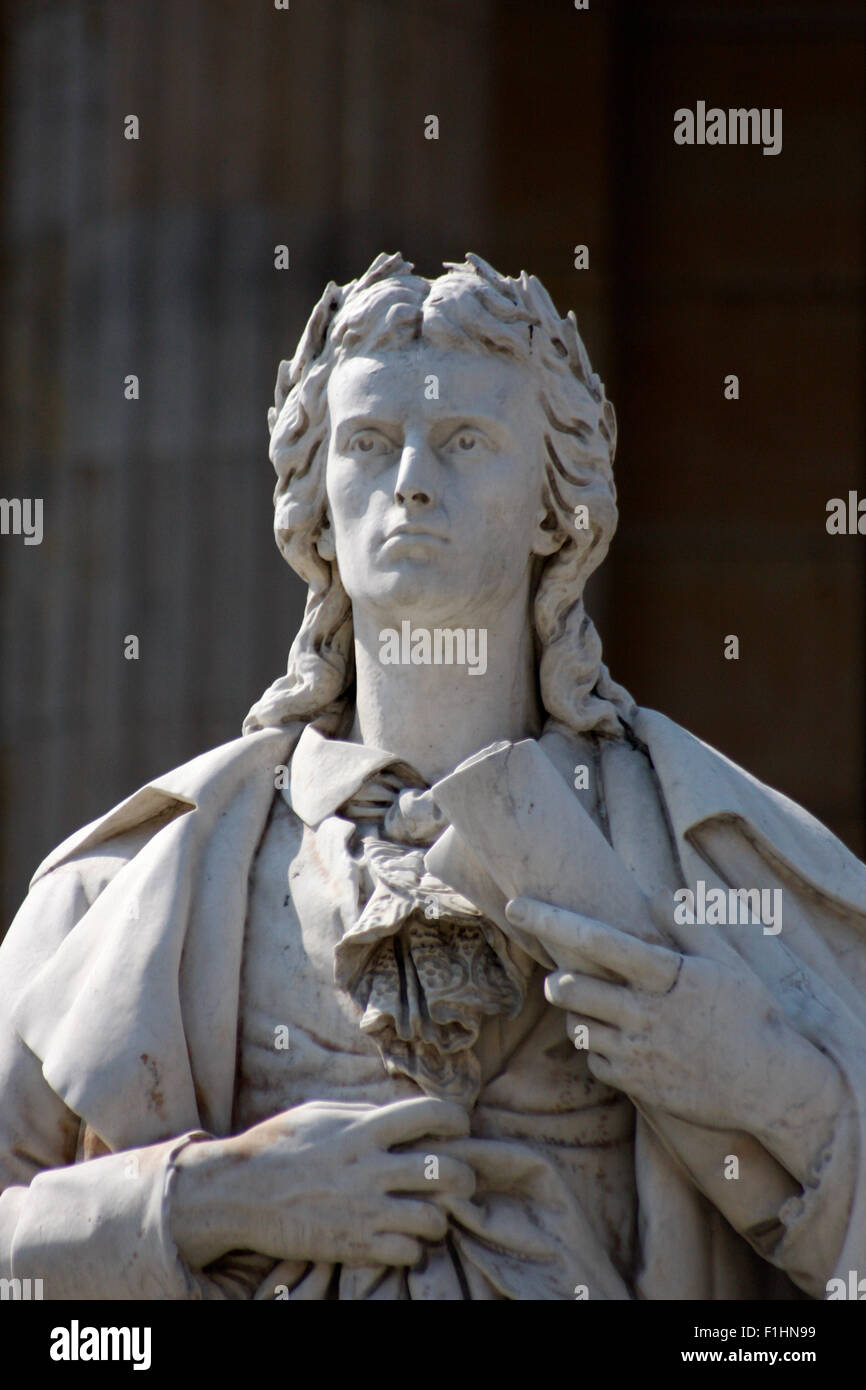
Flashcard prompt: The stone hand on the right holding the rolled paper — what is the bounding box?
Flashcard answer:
[506,898,827,1134]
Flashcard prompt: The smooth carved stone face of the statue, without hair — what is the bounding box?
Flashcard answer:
[320,341,557,624]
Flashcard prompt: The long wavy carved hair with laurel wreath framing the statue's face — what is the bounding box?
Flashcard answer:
[243,254,635,738]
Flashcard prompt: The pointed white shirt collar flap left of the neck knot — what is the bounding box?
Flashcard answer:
[282,724,417,827]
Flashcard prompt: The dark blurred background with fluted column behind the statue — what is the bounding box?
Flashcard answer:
[0,0,866,930]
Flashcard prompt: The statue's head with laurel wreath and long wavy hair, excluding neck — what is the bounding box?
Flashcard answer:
[245,254,632,735]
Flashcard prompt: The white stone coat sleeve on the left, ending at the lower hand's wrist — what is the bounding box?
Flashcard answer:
[0,844,252,1300]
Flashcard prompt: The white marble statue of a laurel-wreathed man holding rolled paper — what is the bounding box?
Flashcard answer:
[0,256,866,1300]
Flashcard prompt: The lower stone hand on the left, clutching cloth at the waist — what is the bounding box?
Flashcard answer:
[170,1097,475,1269]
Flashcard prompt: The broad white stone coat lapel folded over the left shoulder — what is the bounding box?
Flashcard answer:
[14,728,297,1150]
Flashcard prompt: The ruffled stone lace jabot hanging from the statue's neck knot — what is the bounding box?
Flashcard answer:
[335,766,532,1106]
